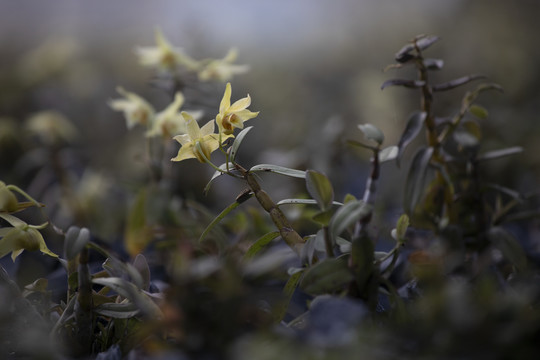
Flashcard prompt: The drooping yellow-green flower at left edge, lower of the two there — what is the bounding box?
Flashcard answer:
[0,214,58,261]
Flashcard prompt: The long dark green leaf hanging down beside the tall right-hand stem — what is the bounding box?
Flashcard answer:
[403,147,433,214]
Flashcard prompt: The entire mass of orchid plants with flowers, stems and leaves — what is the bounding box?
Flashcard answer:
[0,31,540,359]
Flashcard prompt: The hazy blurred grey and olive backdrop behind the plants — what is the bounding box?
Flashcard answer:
[0,0,540,249]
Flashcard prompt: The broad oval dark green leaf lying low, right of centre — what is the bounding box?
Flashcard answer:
[300,257,354,295]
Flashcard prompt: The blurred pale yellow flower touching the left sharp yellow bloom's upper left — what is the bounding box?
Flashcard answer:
[146,92,191,139]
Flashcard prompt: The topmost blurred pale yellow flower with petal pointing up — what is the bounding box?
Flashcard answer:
[135,29,199,71]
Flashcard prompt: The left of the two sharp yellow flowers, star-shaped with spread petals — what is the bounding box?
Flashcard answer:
[171,111,230,163]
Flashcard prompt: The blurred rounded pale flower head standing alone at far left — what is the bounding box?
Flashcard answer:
[26,110,77,145]
